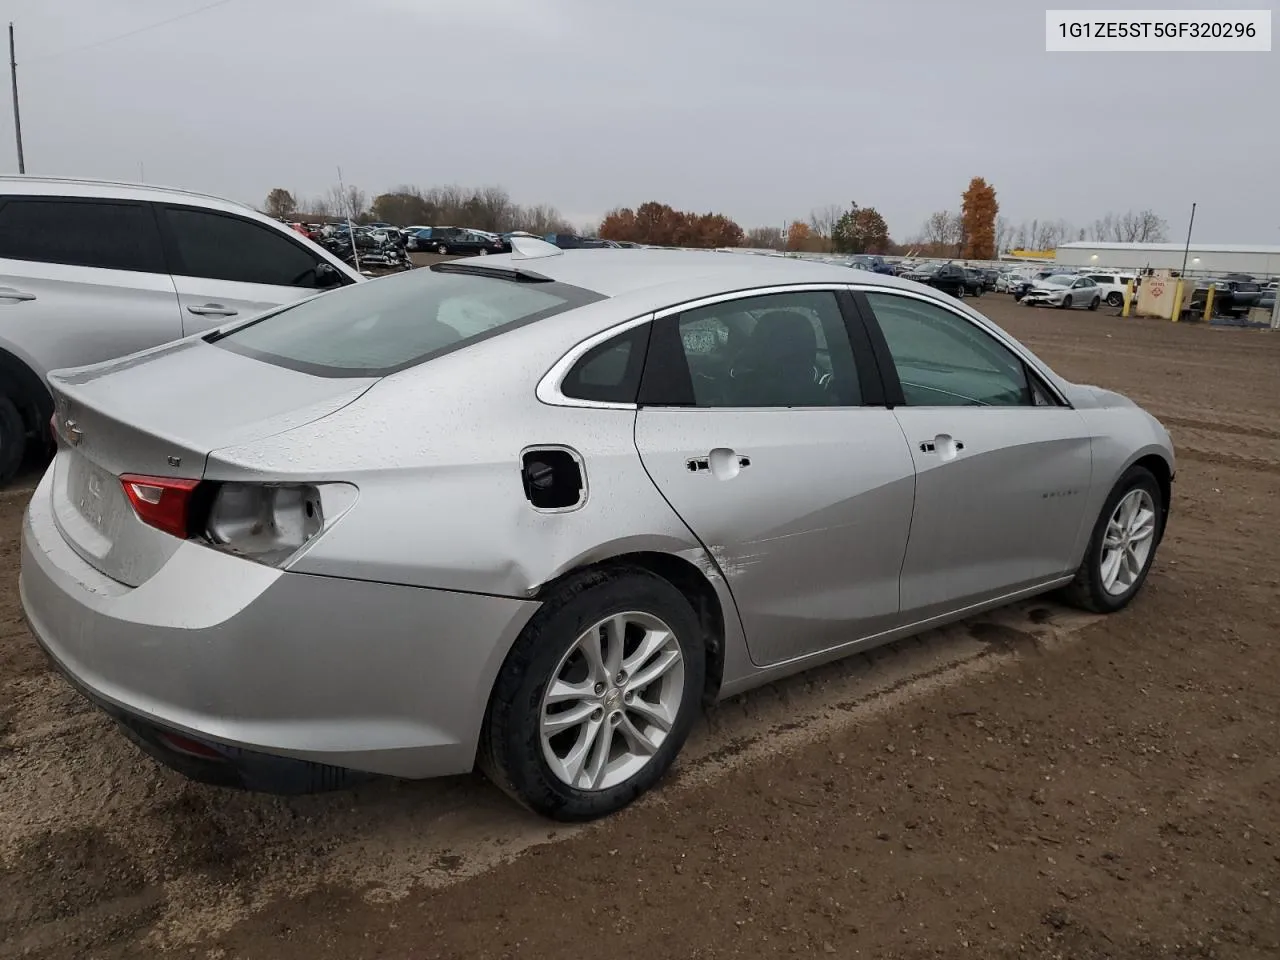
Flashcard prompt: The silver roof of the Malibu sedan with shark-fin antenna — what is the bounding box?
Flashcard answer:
[485,247,918,297]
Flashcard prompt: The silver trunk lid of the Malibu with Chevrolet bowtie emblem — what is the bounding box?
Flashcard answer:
[49,339,375,586]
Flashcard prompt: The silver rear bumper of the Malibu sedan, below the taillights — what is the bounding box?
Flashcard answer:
[19,475,539,788]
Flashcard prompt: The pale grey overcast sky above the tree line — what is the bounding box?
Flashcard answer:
[0,0,1280,244]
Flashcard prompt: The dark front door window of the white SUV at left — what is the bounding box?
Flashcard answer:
[161,206,330,288]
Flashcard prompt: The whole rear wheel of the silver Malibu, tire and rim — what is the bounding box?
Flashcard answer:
[479,568,705,820]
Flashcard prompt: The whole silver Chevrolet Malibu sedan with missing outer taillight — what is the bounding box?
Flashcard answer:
[20,238,1174,819]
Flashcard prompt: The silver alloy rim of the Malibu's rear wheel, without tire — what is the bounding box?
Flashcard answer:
[539,611,685,791]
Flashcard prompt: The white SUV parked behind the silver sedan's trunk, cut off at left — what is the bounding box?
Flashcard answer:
[0,177,361,483]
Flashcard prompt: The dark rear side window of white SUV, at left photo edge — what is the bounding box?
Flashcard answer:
[0,197,168,274]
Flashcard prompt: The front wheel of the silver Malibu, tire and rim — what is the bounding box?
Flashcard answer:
[1065,466,1165,613]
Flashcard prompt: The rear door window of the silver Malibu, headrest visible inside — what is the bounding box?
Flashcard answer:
[645,291,861,407]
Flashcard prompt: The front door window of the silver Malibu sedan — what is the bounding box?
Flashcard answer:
[867,293,1036,407]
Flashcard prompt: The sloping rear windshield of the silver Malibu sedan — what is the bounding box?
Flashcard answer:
[209,269,604,376]
